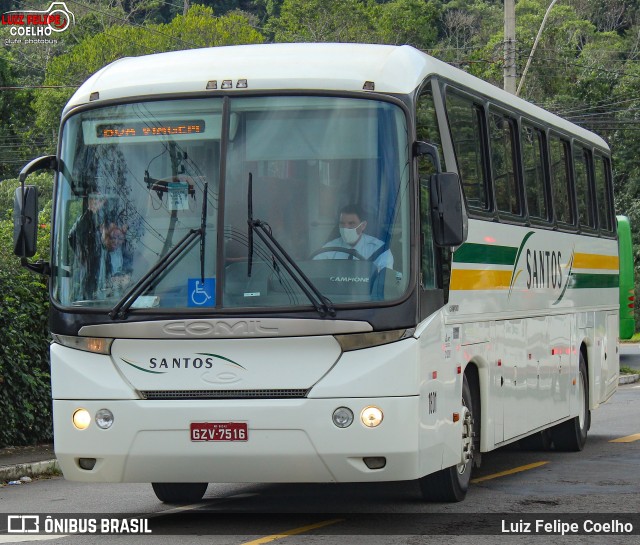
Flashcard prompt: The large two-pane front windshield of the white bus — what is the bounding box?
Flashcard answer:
[52,96,410,310]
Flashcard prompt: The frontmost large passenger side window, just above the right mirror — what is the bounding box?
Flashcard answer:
[447,93,490,210]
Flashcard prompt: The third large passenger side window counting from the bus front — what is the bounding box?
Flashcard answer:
[521,123,549,221]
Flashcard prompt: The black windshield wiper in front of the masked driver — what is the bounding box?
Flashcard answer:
[247,173,336,317]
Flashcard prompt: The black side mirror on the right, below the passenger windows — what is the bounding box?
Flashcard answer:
[429,172,467,247]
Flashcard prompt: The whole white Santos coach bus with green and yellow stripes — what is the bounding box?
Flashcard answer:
[15,44,619,502]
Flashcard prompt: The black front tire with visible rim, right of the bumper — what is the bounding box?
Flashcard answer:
[418,375,476,502]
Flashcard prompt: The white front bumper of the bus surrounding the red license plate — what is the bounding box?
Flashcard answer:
[53,396,420,483]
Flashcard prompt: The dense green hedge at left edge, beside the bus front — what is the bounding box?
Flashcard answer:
[0,174,52,448]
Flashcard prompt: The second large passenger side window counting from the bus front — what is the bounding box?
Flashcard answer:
[489,112,522,215]
